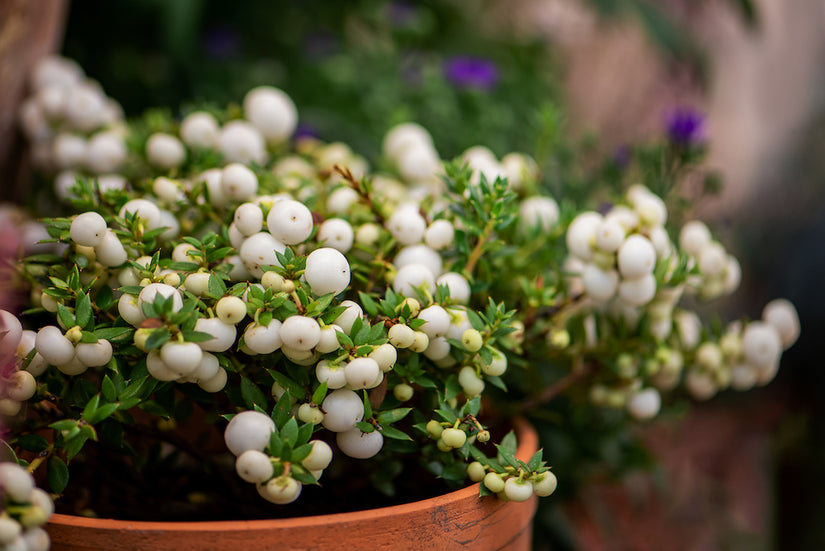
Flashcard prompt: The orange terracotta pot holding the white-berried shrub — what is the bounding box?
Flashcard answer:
[47,422,538,551]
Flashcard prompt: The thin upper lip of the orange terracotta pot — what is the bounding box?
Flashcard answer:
[49,418,538,532]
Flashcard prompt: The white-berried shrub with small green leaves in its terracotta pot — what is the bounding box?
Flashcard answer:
[0,52,799,549]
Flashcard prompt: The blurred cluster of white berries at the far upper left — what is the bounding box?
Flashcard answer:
[20,57,128,203]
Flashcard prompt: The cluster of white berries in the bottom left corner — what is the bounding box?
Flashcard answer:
[0,461,54,551]
